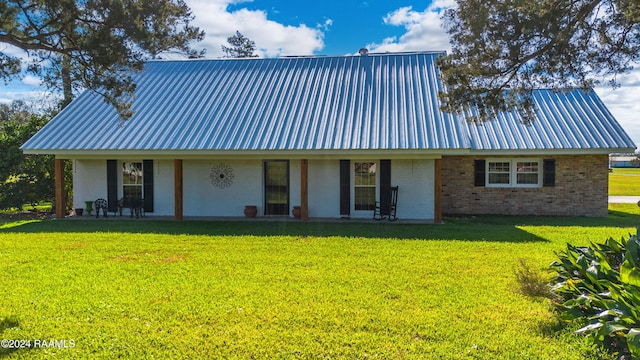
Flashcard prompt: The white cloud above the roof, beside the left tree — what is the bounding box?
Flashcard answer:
[186,0,324,59]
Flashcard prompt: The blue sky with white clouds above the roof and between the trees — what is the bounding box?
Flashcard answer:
[0,0,640,145]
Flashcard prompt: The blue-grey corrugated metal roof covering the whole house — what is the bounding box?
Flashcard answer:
[22,52,635,153]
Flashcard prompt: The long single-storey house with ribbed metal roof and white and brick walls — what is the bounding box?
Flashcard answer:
[22,52,635,222]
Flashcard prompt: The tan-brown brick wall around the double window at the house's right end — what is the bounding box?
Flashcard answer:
[442,154,609,216]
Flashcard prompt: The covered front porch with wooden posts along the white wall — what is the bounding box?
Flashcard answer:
[56,155,442,223]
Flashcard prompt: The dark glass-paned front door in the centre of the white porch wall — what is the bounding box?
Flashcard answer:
[264,160,289,215]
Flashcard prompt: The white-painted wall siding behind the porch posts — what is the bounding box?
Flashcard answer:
[73,160,434,220]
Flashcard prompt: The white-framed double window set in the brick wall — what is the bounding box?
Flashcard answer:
[486,159,542,187]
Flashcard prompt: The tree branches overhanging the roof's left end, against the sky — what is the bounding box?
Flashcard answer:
[0,0,204,119]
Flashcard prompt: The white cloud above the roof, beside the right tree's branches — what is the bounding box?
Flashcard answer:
[367,0,455,52]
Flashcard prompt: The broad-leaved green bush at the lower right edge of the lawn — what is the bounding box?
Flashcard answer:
[551,236,640,359]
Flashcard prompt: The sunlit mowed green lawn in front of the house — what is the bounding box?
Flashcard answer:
[0,212,640,359]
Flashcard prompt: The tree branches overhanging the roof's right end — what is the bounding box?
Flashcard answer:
[440,0,640,122]
